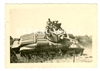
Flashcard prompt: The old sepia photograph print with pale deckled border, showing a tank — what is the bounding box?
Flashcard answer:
[6,4,97,65]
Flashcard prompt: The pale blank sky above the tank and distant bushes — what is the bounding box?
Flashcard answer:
[10,4,97,38]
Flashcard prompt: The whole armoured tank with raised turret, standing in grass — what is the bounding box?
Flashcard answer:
[12,19,84,59]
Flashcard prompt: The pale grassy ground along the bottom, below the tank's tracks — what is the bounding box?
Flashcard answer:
[13,47,92,63]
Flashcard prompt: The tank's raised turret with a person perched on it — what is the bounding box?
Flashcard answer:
[45,19,67,42]
